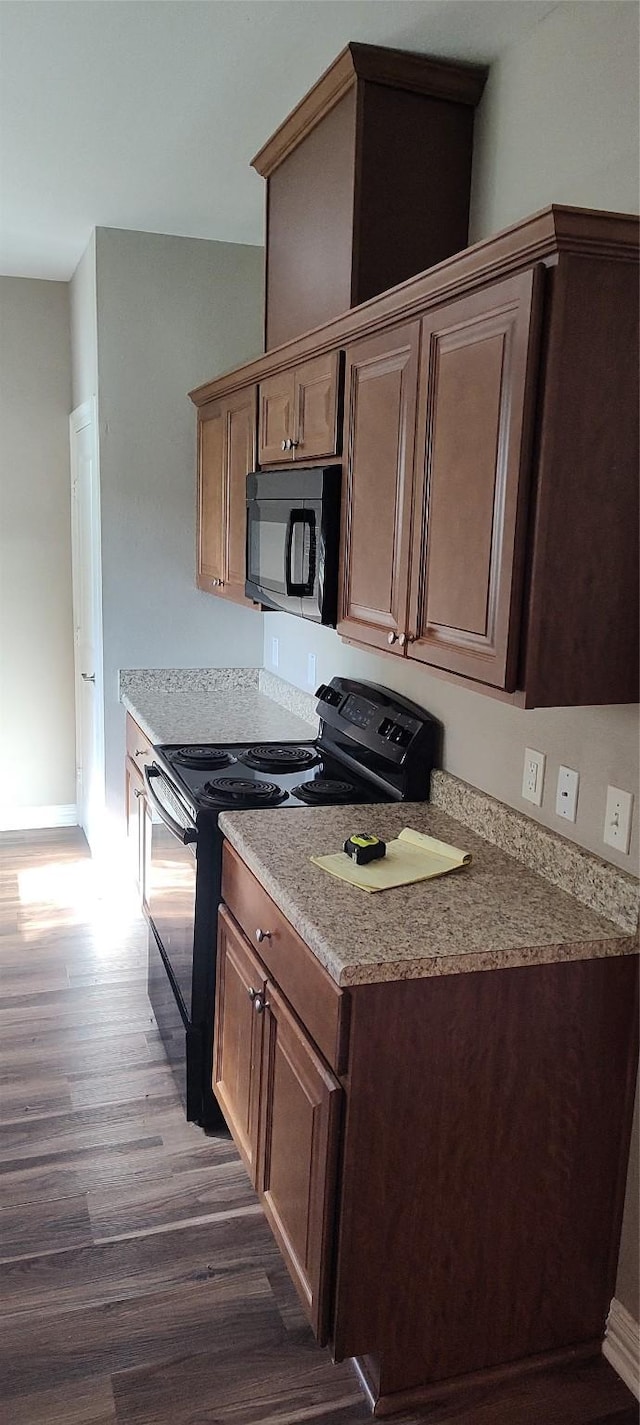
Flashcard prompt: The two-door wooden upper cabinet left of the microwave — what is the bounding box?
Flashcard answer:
[197,386,257,604]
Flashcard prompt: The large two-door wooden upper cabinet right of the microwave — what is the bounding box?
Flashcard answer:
[336,208,639,707]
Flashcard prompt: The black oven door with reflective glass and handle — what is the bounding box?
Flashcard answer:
[144,762,198,1025]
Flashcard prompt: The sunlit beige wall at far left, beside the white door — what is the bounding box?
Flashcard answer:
[0,276,76,825]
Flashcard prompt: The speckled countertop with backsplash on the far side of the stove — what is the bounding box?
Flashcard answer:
[120,668,315,745]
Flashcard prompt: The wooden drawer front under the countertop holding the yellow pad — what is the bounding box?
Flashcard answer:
[222,842,349,1073]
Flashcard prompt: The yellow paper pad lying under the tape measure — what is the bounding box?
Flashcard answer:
[311,827,472,891]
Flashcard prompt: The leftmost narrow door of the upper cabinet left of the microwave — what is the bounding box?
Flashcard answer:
[197,400,227,590]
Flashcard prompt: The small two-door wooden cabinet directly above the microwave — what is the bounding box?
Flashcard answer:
[258,352,342,465]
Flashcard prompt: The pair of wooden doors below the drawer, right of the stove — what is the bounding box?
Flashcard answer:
[212,906,342,1345]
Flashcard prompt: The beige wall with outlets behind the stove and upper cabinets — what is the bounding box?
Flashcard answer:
[265,0,640,1320]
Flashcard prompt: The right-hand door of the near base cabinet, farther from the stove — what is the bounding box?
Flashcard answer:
[258,983,342,1345]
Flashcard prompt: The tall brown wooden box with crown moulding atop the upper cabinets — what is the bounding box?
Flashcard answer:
[252,43,487,351]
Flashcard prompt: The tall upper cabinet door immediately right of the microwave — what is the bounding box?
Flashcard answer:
[338,322,419,656]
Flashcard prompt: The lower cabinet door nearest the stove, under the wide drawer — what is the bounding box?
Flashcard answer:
[212,906,267,1187]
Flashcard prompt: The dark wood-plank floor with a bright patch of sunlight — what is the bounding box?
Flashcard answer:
[0,831,637,1425]
